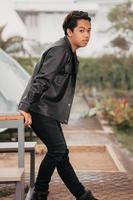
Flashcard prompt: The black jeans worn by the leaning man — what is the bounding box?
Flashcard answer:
[31,112,85,198]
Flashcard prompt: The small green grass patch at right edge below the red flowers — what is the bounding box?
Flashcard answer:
[114,128,133,152]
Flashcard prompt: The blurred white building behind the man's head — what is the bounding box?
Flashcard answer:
[14,0,132,56]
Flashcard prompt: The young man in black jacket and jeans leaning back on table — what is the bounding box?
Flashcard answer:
[19,11,96,200]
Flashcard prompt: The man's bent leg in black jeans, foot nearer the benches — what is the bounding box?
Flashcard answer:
[31,113,66,192]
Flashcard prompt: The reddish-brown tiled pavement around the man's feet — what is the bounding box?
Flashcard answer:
[49,172,133,200]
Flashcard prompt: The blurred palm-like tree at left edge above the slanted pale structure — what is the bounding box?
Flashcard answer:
[0,25,23,53]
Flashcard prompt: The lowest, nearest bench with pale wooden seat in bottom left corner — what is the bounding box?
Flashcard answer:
[0,168,24,200]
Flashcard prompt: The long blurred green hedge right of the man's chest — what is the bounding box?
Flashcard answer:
[78,55,133,90]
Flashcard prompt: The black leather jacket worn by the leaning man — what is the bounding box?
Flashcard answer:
[18,36,79,124]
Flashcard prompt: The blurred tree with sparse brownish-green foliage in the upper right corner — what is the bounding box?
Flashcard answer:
[108,1,133,52]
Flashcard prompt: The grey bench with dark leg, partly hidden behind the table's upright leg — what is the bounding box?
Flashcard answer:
[0,142,36,187]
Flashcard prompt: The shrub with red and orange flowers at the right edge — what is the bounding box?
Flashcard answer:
[100,97,133,129]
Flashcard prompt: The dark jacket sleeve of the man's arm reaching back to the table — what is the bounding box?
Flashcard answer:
[18,46,66,112]
